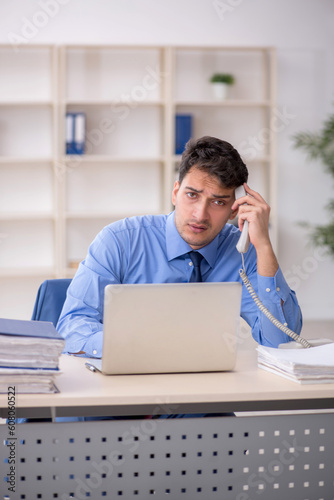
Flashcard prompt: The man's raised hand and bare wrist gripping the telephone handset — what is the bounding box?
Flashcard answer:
[231,184,278,276]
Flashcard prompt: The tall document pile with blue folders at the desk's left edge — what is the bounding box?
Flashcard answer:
[0,318,65,394]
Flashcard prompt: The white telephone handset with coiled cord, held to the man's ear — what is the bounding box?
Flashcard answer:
[235,186,312,348]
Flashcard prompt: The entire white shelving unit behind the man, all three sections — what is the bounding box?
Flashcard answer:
[0,45,277,317]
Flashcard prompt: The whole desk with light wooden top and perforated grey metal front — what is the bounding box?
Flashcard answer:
[0,351,334,500]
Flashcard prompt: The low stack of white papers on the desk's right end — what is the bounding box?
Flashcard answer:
[257,341,334,384]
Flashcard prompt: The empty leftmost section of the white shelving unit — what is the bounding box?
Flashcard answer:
[0,45,59,284]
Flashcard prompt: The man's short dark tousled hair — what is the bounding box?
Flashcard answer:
[179,136,248,188]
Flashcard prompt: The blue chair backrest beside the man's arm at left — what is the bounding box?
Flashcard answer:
[31,279,72,326]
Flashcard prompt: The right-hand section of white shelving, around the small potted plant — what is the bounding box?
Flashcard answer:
[173,47,277,219]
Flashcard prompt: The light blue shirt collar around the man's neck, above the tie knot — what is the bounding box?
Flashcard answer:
[166,211,219,267]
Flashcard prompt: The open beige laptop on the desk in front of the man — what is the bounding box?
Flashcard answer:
[86,282,242,375]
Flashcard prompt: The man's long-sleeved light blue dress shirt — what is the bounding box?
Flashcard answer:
[57,212,302,357]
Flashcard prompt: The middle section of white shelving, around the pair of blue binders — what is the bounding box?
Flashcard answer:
[59,46,167,276]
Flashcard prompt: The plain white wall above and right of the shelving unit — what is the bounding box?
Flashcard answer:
[0,0,334,319]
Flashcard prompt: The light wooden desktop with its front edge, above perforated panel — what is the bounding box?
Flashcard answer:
[0,347,334,417]
